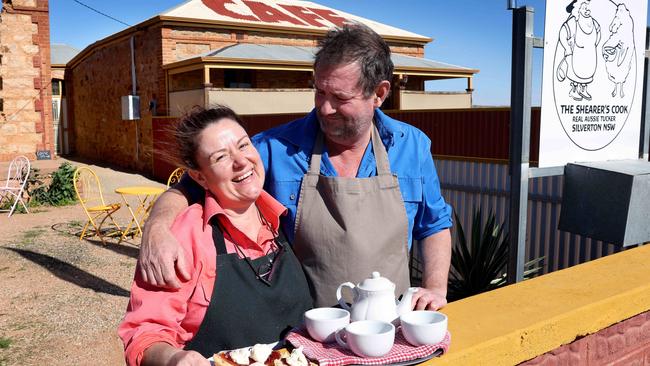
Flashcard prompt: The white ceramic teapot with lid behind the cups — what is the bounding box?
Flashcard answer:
[336,272,418,322]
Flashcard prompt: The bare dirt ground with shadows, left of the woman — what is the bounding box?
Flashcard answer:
[0,159,164,366]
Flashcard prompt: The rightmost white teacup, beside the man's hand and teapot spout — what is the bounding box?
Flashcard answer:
[400,310,447,346]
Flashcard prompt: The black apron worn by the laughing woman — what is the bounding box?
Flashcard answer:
[185,217,313,358]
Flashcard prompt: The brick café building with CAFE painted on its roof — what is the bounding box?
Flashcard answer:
[65,0,478,171]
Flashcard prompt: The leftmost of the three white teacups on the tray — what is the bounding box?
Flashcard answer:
[305,308,350,343]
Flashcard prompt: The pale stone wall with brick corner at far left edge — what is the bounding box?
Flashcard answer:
[0,0,54,161]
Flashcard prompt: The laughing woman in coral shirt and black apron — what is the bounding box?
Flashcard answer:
[118,106,312,365]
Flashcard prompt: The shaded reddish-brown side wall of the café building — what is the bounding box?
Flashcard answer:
[66,27,165,172]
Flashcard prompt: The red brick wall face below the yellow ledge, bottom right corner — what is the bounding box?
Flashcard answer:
[521,312,650,366]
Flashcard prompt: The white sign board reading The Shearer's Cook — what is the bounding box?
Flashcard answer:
[539,0,648,167]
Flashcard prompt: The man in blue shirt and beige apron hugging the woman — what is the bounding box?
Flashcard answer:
[139,24,451,309]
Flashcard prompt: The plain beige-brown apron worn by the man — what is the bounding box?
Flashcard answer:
[293,125,409,306]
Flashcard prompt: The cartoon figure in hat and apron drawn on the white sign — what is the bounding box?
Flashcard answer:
[557,0,600,100]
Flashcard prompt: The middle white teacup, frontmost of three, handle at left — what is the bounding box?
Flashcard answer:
[336,320,395,357]
